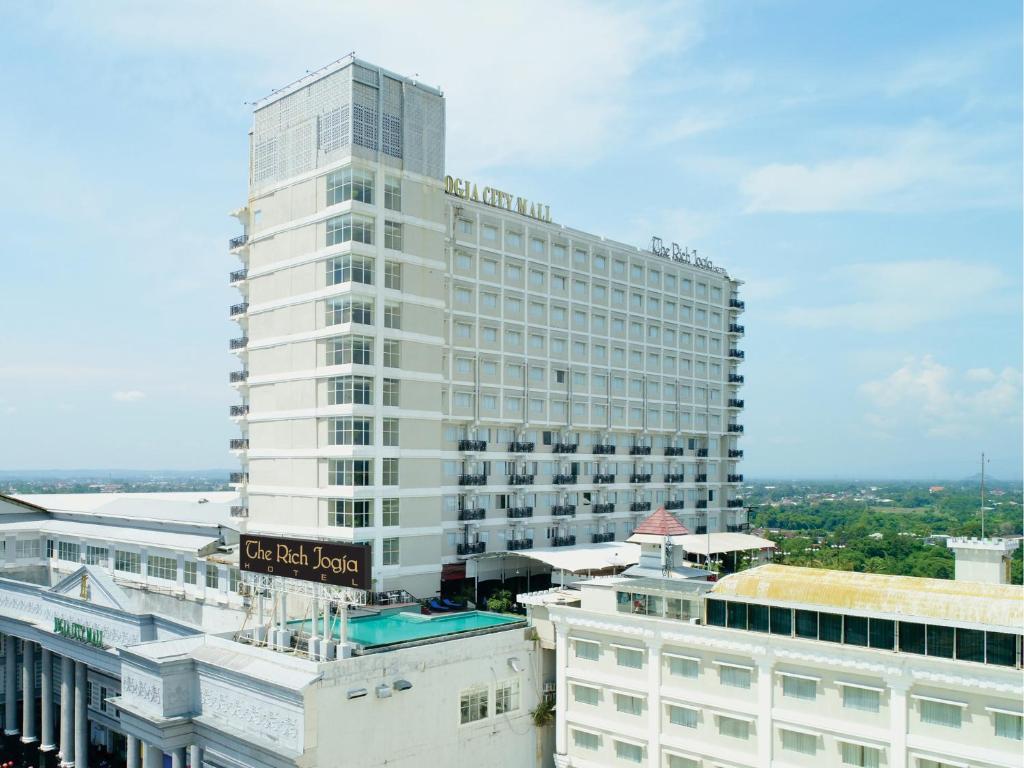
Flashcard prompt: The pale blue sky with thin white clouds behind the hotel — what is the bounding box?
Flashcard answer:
[0,0,1022,478]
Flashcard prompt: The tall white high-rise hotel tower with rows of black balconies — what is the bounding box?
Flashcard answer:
[230,58,746,597]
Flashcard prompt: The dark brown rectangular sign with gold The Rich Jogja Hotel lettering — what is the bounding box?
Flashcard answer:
[239,535,370,590]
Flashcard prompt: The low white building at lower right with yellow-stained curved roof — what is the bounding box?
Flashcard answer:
[519,524,1024,768]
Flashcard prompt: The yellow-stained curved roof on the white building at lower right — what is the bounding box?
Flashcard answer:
[710,564,1024,632]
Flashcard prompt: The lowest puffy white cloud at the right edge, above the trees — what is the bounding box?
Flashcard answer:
[860,355,1022,438]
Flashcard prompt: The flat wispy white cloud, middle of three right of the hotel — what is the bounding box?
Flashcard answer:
[780,259,1009,333]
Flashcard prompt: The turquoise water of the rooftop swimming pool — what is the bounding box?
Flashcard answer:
[289,610,522,647]
